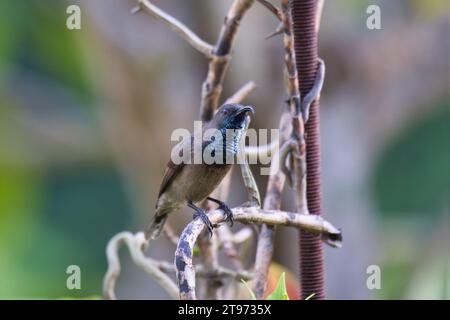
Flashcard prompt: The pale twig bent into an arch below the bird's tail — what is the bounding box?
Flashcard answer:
[103,231,178,299]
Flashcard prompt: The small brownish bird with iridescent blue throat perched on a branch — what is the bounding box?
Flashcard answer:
[146,103,254,239]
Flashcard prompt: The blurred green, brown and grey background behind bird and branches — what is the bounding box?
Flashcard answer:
[0,0,450,299]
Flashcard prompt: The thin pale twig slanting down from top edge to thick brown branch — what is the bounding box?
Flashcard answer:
[138,0,214,58]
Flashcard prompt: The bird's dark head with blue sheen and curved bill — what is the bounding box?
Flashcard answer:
[212,103,254,130]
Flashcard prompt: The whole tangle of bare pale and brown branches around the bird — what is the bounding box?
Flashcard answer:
[103,0,342,299]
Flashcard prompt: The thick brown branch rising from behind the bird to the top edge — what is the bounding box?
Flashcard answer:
[200,0,254,121]
